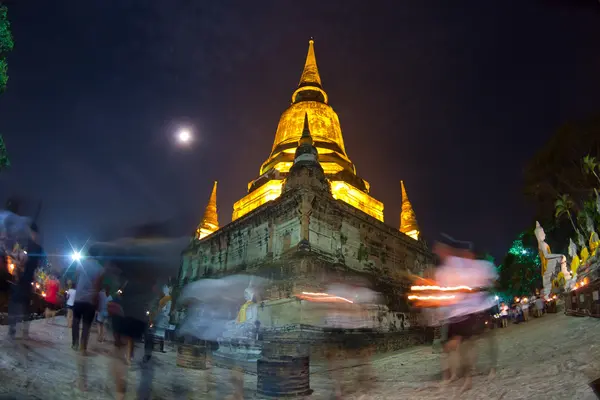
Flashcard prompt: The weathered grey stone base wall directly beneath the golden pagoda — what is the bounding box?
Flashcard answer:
[180,187,432,311]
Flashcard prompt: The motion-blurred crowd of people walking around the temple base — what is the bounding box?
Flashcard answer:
[0,205,576,399]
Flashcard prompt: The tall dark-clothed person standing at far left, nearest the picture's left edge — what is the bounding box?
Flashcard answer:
[8,223,45,339]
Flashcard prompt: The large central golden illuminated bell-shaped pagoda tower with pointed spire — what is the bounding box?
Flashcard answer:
[232,40,383,222]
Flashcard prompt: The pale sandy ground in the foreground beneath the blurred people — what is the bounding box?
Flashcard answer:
[0,314,600,400]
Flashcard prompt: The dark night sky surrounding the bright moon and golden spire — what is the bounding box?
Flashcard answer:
[0,0,600,257]
